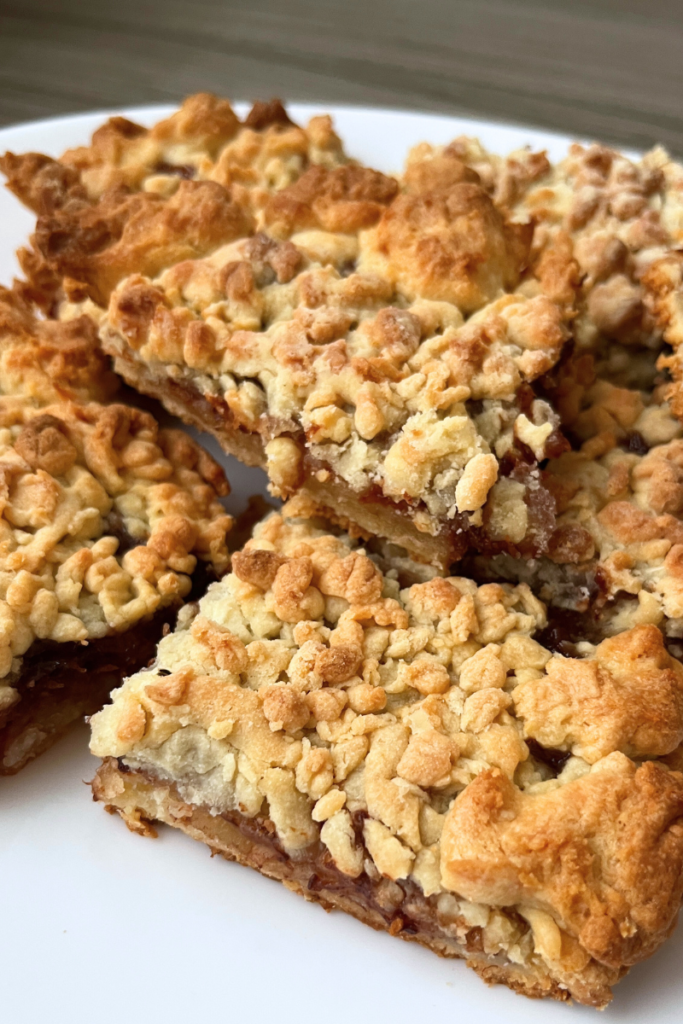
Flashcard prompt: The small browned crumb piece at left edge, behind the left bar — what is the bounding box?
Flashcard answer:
[0,286,118,406]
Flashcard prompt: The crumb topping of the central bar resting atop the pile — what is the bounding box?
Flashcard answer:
[102,220,568,537]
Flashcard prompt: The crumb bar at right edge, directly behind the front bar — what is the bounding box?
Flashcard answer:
[475,389,683,638]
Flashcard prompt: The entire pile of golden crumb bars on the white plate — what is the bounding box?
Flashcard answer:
[0,94,683,1007]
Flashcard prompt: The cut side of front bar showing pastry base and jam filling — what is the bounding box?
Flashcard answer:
[92,758,617,1008]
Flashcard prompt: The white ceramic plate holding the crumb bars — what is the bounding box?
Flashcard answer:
[0,104,683,1024]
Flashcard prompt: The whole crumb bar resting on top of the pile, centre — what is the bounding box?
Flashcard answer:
[93,168,571,566]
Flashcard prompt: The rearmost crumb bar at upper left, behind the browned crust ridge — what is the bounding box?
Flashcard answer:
[1,92,346,213]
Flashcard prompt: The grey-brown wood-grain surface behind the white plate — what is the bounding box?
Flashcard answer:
[0,0,683,156]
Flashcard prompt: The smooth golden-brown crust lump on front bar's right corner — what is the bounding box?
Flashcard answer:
[441,753,682,970]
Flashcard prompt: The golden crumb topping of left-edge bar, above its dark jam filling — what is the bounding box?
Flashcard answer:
[0,397,230,693]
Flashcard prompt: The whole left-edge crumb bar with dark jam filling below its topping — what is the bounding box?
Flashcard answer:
[0,397,230,774]
